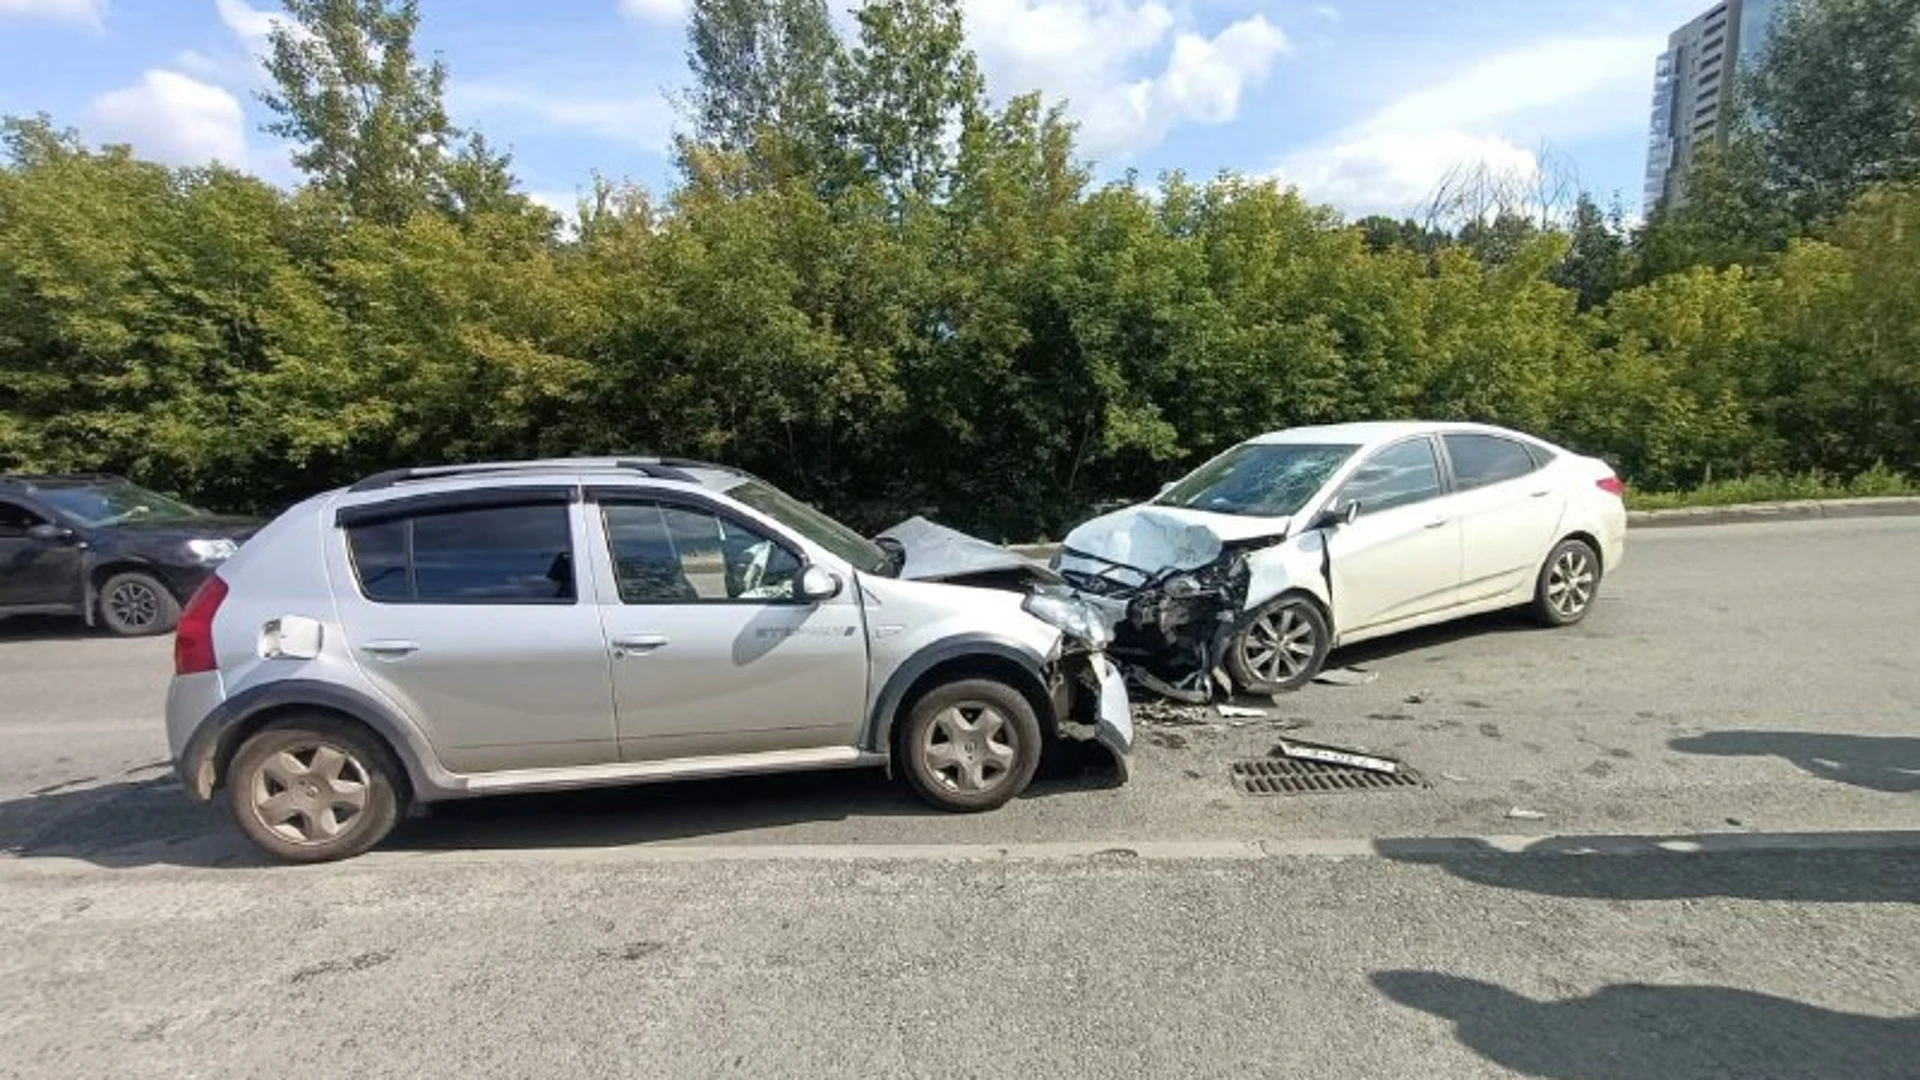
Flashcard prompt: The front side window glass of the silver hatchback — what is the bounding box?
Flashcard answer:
[601,502,801,603]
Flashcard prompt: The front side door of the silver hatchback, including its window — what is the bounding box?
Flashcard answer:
[593,488,868,761]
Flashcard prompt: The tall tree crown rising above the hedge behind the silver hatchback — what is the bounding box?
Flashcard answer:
[261,0,456,225]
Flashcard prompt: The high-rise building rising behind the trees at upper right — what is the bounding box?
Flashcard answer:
[1644,0,1784,213]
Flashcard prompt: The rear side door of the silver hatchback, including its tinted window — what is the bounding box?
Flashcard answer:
[328,486,618,773]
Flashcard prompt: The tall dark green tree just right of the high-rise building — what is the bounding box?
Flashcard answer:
[1745,0,1920,223]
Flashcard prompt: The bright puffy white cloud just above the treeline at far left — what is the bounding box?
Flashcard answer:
[86,67,248,165]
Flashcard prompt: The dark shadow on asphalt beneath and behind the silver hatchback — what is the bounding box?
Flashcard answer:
[0,746,1114,867]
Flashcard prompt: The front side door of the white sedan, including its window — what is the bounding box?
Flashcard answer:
[1327,434,1461,636]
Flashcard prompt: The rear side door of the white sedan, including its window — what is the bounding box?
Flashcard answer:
[1442,432,1567,603]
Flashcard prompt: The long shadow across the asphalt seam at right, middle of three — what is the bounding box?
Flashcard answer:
[1373,832,1920,903]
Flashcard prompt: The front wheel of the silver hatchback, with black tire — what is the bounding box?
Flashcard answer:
[895,678,1041,813]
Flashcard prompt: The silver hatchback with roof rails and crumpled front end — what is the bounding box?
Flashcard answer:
[167,459,1133,861]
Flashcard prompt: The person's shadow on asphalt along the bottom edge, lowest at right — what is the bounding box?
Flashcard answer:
[1371,970,1920,1080]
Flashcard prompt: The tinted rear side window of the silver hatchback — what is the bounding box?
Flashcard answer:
[348,503,576,603]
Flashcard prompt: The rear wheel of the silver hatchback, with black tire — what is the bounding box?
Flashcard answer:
[227,717,401,863]
